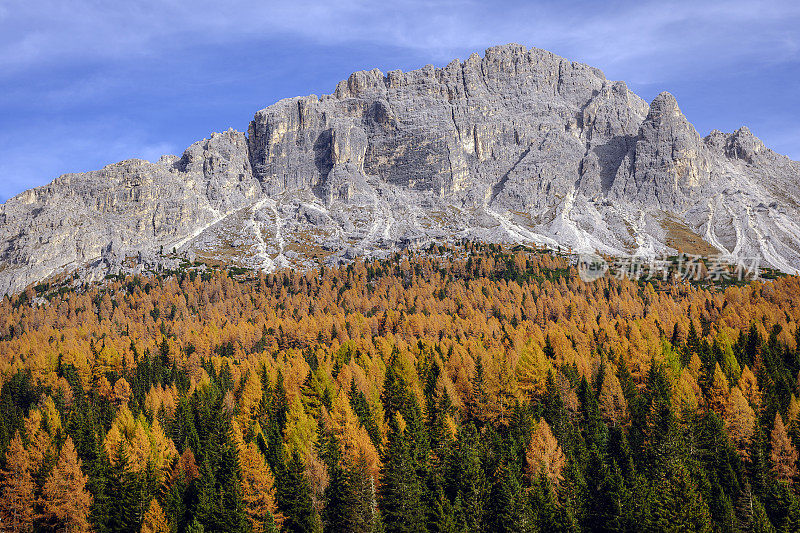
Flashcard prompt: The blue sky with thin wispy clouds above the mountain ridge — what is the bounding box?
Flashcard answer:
[0,0,800,201]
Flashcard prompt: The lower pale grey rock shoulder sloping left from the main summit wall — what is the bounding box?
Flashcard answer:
[0,131,261,292]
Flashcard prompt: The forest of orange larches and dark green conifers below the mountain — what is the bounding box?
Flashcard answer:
[0,243,800,533]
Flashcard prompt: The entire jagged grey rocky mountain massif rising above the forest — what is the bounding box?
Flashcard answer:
[0,45,800,293]
